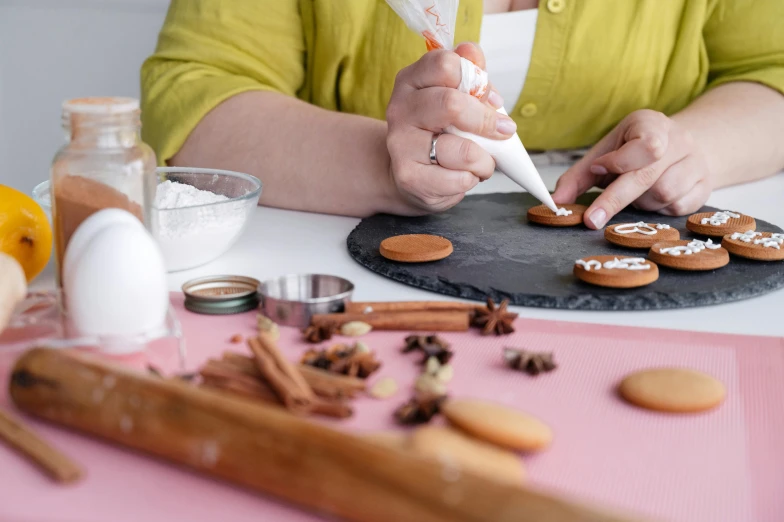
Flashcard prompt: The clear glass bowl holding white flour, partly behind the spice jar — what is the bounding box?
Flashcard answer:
[33,167,262,272]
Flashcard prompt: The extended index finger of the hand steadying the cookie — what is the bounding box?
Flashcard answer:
[585,162,664,230]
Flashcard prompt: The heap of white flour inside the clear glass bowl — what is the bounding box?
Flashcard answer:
[153,180,248,272]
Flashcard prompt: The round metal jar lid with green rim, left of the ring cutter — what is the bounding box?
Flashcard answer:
[182,275,260,315]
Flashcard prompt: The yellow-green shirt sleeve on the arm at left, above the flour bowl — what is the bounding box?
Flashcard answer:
[141,0,305,164]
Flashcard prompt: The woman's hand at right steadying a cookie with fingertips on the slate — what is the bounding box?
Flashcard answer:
[553,110,712,229]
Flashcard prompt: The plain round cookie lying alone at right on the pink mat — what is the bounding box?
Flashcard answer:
[618,368,726,413]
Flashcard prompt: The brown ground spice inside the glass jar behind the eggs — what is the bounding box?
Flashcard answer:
[52,175,144,276]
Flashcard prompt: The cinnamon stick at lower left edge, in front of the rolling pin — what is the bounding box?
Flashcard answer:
[0,410,82,484]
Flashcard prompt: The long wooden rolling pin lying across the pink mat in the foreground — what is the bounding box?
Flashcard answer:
[10,348,644,522]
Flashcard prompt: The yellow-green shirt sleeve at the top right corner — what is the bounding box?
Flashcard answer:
[703,0,784,94]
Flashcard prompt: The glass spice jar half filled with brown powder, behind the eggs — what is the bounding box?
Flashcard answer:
[51,97,157,287]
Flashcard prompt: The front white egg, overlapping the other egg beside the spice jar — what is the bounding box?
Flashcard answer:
[63,221,169,349]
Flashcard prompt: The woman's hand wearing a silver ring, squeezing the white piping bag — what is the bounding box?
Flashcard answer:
[387,44,517,212]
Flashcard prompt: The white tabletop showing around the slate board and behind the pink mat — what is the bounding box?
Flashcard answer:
[34,167,784,337]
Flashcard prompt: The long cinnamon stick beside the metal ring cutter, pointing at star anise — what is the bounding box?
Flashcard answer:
[311,311,470,332]
